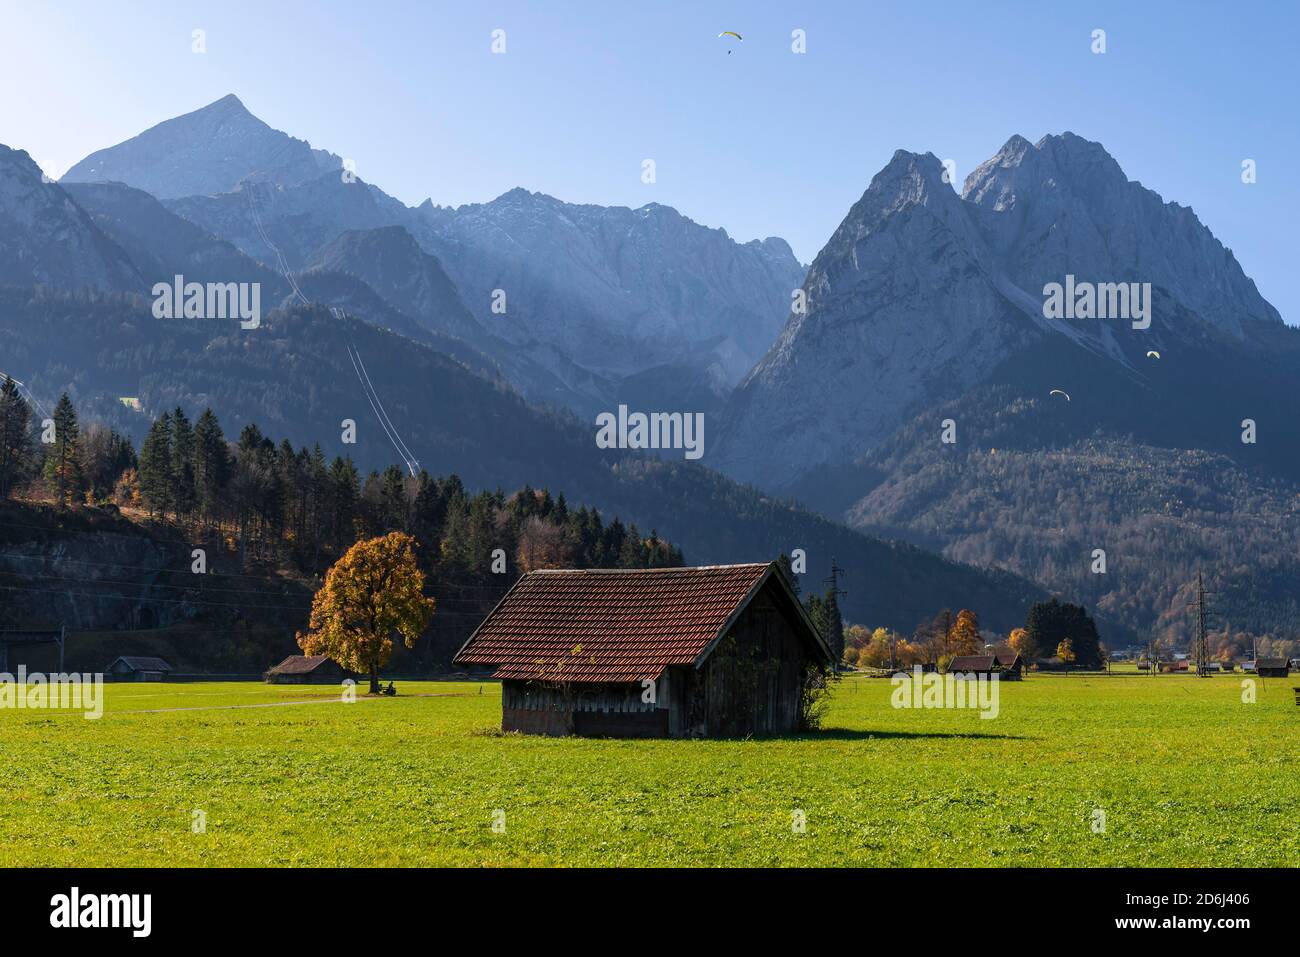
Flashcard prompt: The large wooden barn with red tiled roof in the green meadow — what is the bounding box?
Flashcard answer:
[455,563,835,737]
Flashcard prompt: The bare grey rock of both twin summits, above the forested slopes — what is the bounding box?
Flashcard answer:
[709,133,1281,489]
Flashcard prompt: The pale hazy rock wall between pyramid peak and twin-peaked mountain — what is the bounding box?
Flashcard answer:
[416,189,803,385]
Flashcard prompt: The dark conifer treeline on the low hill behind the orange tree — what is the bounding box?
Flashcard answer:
[0,378,683,581]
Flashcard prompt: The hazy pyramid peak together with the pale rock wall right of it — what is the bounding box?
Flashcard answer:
[65,96,803,417]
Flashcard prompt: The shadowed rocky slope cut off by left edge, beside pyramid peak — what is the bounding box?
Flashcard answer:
[0,146,144,291]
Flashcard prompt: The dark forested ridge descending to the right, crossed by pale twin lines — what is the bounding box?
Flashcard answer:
[0,287,1041,628]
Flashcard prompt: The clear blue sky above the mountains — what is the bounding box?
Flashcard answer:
[0,0,1300,322]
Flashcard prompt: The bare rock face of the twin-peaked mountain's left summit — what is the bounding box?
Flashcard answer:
[706,151,1027,488]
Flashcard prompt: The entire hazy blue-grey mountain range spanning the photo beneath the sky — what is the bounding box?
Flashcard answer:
[0,96,1300,644]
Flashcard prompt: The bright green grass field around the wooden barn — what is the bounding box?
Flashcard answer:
[0,675,1300,866]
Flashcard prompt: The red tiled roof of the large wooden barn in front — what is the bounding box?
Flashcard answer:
[455,564,779,683]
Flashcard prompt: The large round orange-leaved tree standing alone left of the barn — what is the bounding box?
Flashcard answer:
[298,532,434,694]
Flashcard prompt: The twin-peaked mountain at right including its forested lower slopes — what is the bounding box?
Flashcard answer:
[706,133,1300,641]
